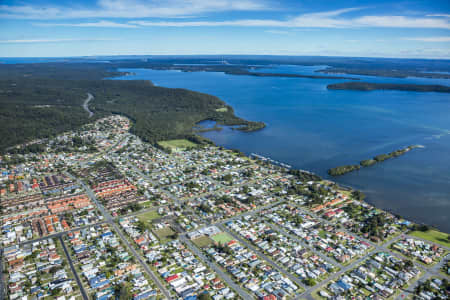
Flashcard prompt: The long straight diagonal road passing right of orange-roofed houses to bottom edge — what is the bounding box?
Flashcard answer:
[78,180,171,299]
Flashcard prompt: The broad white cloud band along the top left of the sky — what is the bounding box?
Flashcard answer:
[0,0,269,20]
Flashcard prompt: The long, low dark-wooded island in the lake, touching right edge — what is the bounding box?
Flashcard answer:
[327,81,450,93]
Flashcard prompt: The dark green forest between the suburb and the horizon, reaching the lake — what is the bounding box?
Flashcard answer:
[0,63,265,151]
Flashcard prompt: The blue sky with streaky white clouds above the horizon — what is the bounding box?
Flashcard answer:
[0,0,450,59]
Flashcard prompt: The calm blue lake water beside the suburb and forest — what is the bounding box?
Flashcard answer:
[115,66,450,232]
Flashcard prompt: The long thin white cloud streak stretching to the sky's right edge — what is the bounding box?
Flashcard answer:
[129,8,450,29]
